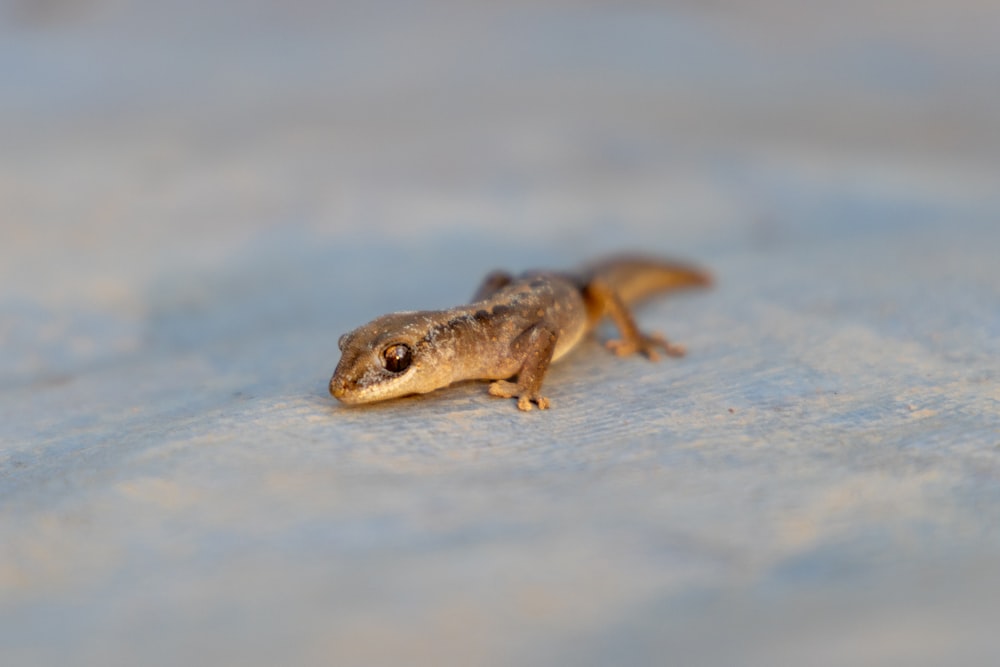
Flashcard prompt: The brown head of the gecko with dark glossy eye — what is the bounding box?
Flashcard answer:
[330,312,451,404]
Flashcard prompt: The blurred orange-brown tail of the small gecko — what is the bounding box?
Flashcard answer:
[585,255,712,304]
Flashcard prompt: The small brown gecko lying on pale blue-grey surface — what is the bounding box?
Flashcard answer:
[330,257,712,410]
